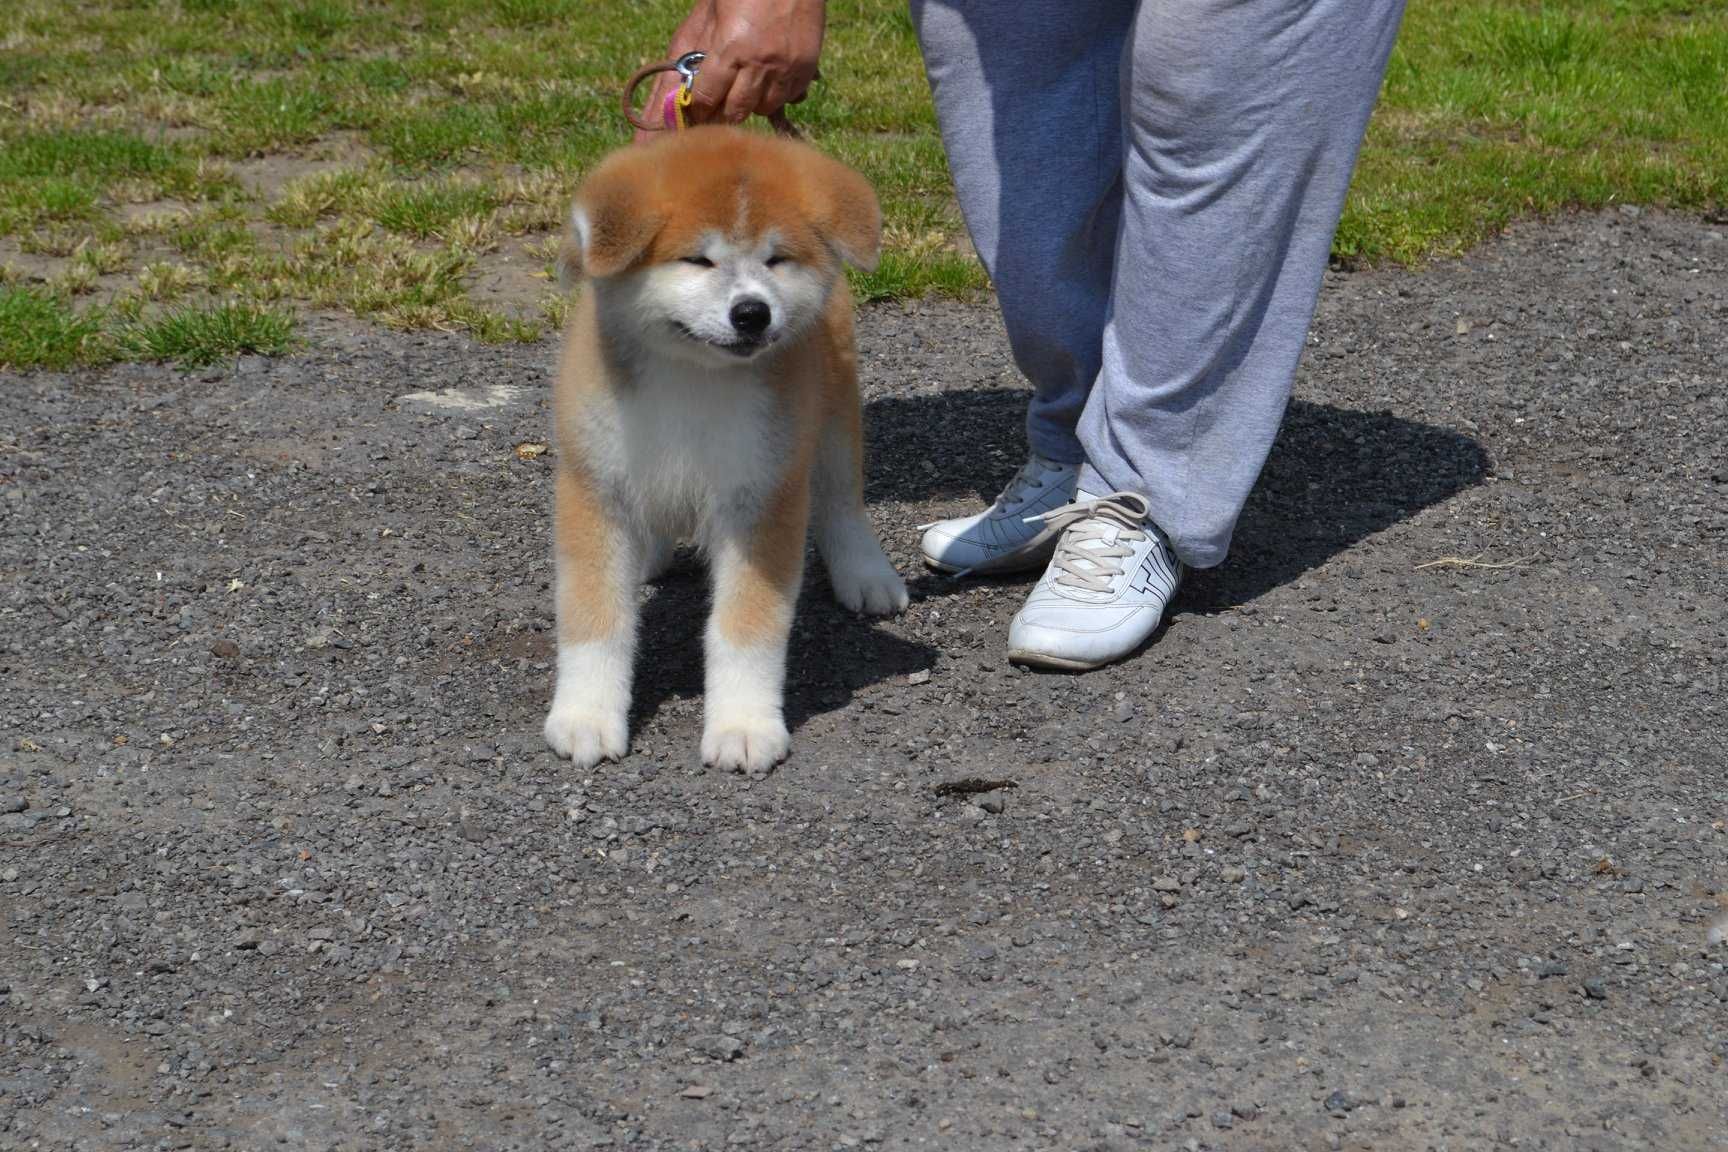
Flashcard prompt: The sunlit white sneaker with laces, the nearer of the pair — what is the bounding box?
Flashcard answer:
[1007,492,1182,670]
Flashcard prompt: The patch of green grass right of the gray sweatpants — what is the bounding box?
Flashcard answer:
[1334,0,1728,263]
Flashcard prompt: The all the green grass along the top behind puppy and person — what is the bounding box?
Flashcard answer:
[0,0,1728,366]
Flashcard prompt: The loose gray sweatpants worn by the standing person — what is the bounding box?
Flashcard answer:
[912,0,1403,568]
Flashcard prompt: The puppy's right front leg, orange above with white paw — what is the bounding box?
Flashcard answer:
[702,468,810,772]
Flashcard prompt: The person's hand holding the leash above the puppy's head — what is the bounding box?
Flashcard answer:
[636,0,828,140]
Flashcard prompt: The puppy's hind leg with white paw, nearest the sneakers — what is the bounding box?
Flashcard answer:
[814,397,907,617]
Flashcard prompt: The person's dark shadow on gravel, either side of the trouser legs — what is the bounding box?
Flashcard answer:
[864,389,1490,611]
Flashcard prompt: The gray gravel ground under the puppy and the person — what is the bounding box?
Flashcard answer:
[0,212,1728,1152]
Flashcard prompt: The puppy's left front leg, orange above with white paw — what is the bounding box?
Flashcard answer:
[546,465,643,769]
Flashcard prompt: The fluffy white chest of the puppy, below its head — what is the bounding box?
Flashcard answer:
[584,370,788,530]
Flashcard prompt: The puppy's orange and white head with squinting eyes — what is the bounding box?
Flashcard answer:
[560,128,881,364]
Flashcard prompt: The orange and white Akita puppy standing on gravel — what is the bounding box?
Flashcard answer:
[546,128,907,772]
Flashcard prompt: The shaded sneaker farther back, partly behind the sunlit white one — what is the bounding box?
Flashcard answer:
[918,454,1080,575]
